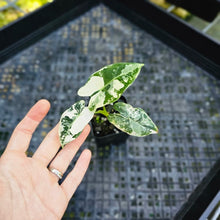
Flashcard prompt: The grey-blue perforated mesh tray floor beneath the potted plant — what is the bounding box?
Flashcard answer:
[0,5,220,220]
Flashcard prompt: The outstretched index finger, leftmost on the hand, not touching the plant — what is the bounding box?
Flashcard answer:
[6,99,50,152]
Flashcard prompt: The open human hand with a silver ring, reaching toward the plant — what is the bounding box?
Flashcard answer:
[0,100,91,220]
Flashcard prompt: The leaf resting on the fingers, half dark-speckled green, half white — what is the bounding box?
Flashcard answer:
[59,100,94,147]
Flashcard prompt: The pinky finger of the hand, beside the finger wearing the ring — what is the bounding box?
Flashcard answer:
[61,149,91,200]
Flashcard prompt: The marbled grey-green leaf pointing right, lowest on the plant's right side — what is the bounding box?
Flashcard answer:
[107,102,158,137]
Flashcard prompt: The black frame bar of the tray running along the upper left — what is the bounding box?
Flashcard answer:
[0,0,98,63]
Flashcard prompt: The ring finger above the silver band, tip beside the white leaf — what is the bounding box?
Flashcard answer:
[49,125,90,179]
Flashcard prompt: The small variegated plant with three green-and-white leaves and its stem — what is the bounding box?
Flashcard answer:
[59,63,158,147]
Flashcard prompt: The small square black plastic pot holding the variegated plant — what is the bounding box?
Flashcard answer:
[91,96,129,147]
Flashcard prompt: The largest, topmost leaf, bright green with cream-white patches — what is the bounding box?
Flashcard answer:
[78,63,143,111]
